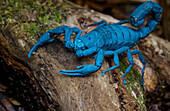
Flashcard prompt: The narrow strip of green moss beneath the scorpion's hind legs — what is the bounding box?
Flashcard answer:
[119,58,145,110]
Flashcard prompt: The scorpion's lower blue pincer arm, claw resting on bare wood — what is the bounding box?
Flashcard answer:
[60,49,104,76]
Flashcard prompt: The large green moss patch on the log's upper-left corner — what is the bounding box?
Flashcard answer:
[0,0,68,40]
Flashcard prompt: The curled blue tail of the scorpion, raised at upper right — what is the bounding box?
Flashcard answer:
[130,1,162,38]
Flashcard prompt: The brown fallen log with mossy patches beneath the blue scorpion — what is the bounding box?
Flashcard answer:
[0,1,169,111]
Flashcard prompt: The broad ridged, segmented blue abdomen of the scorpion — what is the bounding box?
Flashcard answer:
[86,24,140,50]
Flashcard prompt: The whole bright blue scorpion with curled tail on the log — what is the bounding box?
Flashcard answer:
[28,1,162,85]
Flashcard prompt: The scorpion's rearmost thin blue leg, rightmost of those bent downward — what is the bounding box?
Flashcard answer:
[131,49,146,85]
